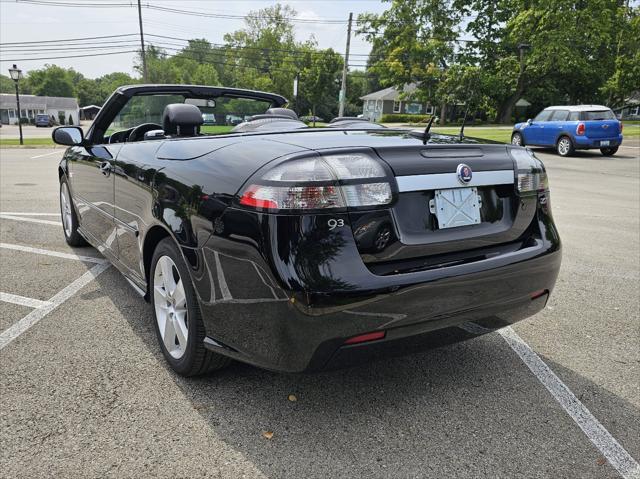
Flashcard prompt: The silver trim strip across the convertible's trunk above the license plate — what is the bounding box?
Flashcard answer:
[396,170,515,193]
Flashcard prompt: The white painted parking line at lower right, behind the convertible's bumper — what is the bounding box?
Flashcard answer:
[498,327,640,479]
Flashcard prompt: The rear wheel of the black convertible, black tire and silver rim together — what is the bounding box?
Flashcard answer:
[149,238,231,376]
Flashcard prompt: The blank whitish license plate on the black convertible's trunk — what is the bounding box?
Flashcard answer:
[429,188,482,229]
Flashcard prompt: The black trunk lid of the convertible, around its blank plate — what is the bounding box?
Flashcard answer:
[350,144,537,274]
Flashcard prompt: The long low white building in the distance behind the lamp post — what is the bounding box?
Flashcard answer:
[0,93,79,125]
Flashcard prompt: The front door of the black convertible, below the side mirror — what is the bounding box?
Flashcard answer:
[68,144,120,254]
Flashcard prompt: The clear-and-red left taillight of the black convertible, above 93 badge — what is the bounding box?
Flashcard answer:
[240,153,393,210]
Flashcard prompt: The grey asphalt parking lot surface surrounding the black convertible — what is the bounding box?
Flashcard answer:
[0,141,640,478]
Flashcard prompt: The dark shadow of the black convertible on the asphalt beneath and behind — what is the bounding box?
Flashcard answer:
[97,272,639,478]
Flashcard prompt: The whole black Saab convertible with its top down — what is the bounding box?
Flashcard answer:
[53,85,561,375]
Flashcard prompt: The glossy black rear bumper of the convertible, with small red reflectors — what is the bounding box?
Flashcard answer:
[195,212,561,372]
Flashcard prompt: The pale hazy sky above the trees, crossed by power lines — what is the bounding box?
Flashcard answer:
[0,0,388,78]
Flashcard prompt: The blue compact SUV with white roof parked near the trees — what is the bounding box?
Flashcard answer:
[511,105,622,156]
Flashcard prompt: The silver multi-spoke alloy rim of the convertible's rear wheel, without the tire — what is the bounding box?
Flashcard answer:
[153,255,189,359]
